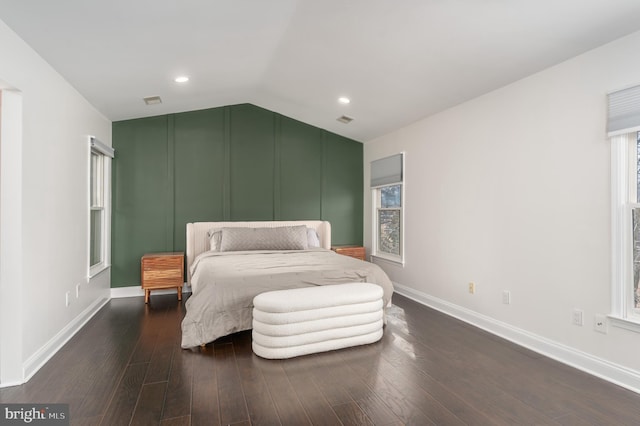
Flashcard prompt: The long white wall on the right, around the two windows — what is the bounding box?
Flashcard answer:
[364,29,640,390]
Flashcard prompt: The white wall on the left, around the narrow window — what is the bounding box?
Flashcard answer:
[0,21,111,386]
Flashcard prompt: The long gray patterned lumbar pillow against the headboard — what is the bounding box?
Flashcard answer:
[220,225,309,251]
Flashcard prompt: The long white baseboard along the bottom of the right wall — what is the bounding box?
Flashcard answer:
[393,282,640,393]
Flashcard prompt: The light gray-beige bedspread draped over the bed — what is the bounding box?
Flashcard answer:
[182,249,393,348]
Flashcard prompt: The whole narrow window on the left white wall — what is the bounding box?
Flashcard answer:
[89,137,113,276]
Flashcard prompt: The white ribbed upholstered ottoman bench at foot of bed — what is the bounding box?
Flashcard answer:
[252,283,384,359]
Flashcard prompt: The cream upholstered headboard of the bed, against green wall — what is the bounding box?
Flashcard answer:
[186,220,331,283]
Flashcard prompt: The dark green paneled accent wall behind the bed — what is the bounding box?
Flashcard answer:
[111,104,363,287]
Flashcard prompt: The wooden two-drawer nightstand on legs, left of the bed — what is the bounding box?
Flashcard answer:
[140,252,184,303]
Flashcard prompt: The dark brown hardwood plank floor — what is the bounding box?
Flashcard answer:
[0,295,640,426]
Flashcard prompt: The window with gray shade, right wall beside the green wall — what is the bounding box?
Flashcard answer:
[371,154,404,263]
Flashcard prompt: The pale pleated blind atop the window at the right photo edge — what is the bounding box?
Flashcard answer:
[607,86,640,136]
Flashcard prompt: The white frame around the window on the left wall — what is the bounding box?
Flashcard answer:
[87,136,114,278]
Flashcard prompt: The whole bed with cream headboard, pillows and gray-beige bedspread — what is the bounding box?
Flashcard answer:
[181,221,393,348]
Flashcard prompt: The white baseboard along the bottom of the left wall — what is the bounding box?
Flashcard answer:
[20,298,109,386]
